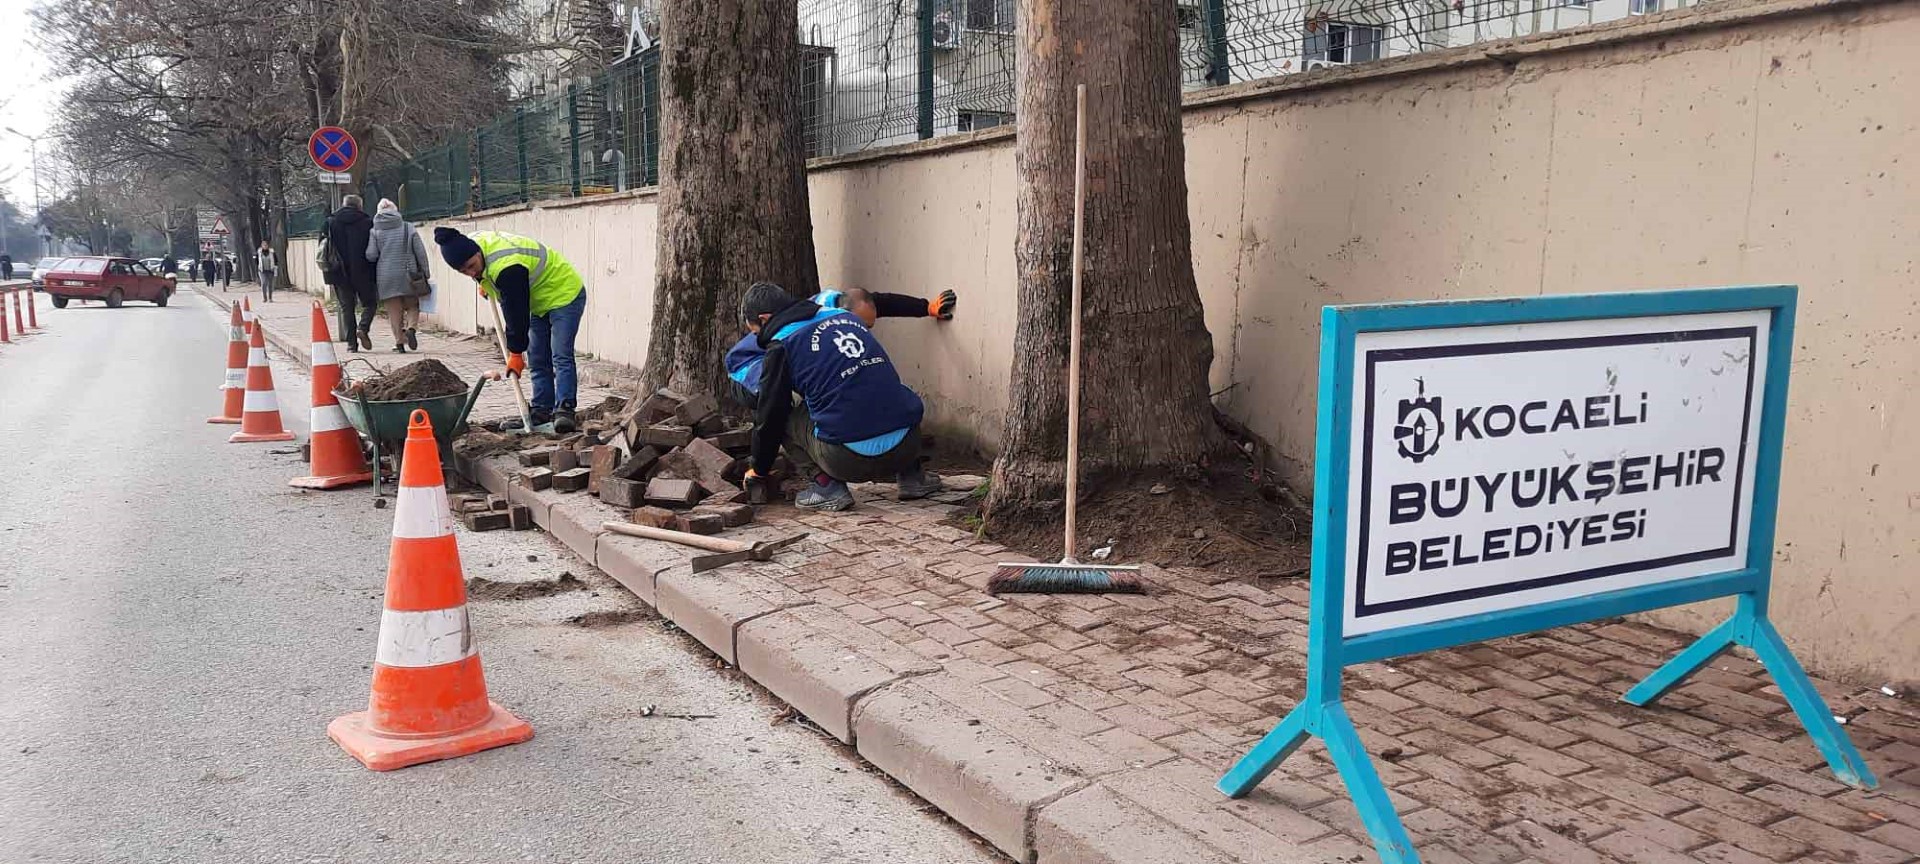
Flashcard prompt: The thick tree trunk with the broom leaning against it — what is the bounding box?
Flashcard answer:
[987,0,1219,520]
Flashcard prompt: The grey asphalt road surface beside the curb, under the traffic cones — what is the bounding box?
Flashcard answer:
[0,292,995,862]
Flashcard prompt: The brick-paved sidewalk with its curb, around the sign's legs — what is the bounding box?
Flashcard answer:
[228,278,1920,864]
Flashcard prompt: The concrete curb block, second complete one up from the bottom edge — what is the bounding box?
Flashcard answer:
[737,611,939,743]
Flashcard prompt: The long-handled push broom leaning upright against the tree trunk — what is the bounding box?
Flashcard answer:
[987,84,1146,593]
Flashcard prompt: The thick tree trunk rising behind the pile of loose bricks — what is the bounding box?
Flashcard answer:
[645,0,820,394]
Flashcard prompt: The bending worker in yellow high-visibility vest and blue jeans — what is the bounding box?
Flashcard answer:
[434,227,588,432]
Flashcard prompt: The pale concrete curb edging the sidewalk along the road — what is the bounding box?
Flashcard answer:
[457,457,1113,862]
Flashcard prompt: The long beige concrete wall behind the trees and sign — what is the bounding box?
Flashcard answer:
[294,0,1920,684]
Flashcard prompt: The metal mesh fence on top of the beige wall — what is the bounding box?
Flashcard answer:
[288,0,1697,234]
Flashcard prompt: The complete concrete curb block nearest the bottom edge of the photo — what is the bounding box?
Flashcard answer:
[854,682,1081,860]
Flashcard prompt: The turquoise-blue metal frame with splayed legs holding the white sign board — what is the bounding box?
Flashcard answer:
[1217,284,1878,864]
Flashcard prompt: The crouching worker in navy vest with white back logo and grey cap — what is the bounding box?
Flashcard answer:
[741,282,941,511]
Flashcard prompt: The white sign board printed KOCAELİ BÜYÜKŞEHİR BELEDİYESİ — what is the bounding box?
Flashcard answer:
[1344,309,1770,636]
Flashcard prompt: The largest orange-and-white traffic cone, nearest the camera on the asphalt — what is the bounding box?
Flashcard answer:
[326,409,534,772]
